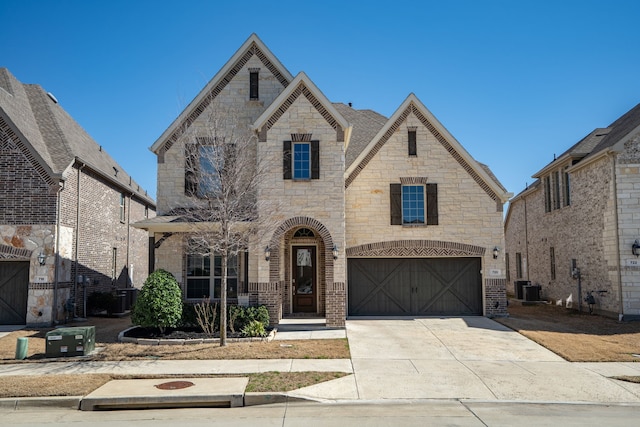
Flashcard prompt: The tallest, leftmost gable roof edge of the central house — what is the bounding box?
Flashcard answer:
[150,34,293,154]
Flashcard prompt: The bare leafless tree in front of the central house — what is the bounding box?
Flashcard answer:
[174,100,278,346]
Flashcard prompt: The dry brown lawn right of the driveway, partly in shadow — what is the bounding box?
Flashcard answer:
[496,302,640,362]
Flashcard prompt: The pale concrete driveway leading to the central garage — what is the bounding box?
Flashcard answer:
[346,317,640,403]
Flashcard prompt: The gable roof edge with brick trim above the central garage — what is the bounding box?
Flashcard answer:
[345,93,511,203]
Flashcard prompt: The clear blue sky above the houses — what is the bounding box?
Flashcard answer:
[0,0,640,204]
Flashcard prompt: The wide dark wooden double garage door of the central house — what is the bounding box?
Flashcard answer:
[348,258,482,316]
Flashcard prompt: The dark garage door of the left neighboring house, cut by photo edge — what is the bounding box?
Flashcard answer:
[0,261,29,325]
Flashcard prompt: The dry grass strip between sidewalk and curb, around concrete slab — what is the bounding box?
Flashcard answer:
[0,372,348,398]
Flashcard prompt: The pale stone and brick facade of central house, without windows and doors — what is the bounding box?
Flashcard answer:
[146,35,507,327]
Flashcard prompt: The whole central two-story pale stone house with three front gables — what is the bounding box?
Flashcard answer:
[137,35,510,326]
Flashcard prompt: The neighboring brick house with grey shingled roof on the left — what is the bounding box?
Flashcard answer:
[0,68,155,325]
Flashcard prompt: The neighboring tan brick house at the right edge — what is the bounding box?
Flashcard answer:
[505,104,640,319]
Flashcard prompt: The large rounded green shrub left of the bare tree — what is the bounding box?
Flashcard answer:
[131,270,182,333]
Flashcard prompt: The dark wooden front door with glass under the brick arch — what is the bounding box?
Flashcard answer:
[291,246,317,313]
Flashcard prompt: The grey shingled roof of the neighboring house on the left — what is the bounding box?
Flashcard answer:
[0,68,155,205]
